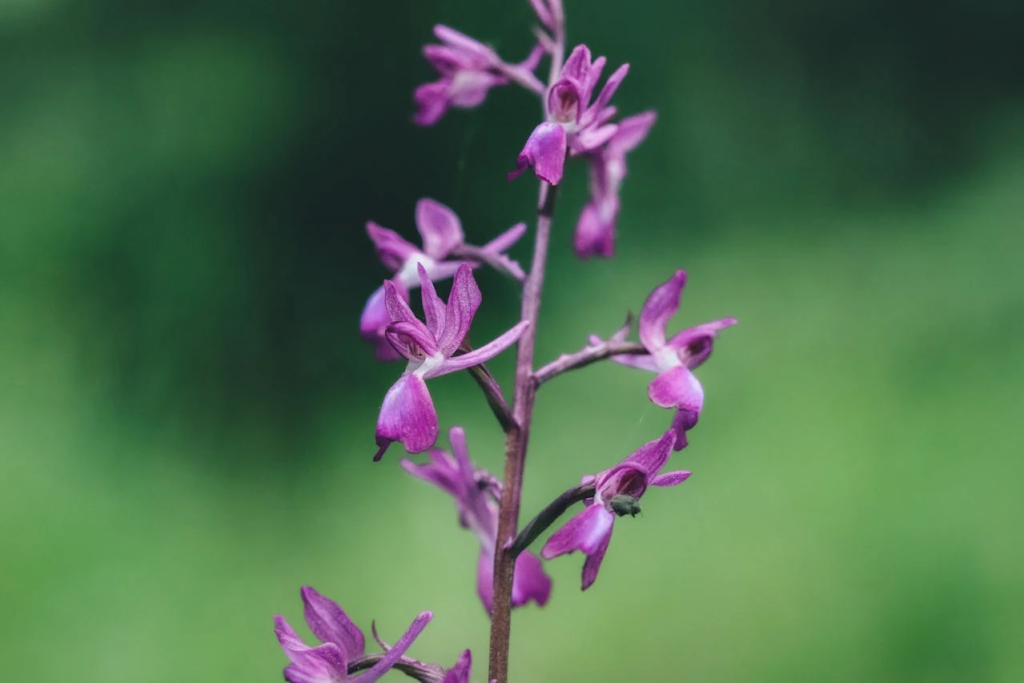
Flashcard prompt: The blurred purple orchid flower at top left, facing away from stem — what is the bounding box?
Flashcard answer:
[413,25,544,126]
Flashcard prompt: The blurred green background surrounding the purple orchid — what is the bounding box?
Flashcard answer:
[0,0,1024,683]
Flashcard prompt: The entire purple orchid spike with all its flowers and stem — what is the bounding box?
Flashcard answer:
[275,0,736,683]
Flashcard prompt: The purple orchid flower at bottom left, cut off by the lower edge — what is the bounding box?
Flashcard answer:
[273,586,432,683]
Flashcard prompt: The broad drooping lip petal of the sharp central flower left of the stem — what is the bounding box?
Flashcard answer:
[374,374,438,460]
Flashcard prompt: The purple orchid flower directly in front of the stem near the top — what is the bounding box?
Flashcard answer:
[508,45,630,185]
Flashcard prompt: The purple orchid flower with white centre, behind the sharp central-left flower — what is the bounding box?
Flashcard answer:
[359,198,526,360]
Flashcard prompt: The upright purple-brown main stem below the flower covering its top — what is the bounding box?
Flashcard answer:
[487,182,558,683]
